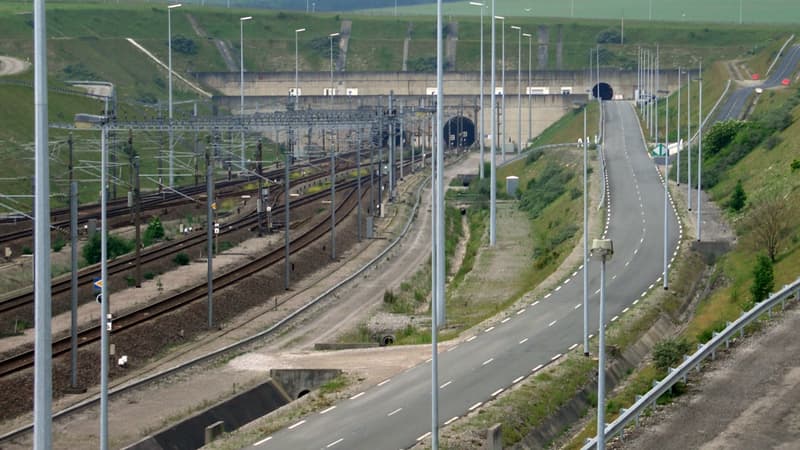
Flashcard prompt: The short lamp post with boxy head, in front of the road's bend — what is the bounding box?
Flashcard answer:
[592,239,614,450]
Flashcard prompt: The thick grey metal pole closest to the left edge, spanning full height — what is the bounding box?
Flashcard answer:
[33,0,52,450]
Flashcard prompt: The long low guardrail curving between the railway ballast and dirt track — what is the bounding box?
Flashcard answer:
[0,169,430,442]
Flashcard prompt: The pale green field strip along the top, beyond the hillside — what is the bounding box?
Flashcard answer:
[365,0,800,24]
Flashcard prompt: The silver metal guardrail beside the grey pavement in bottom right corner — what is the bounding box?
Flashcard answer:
[582,278,800,450]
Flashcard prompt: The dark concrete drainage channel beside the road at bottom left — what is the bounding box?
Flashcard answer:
[125,369,342,450]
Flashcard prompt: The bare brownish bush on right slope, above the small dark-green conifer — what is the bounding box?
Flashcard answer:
[746,188,793,263]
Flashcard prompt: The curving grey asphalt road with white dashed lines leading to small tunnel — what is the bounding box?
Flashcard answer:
[251,102,678,450]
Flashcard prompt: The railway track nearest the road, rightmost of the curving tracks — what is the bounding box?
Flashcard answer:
[0,180,366,377]
